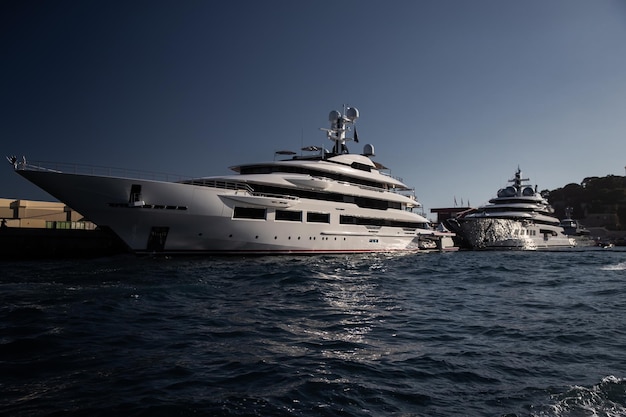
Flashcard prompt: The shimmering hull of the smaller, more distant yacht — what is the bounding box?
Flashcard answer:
[460,217,576,250]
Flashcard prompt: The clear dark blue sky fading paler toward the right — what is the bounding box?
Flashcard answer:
[0,0,626,214]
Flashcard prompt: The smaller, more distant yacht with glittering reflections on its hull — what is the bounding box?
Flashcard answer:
[448,168,576,250]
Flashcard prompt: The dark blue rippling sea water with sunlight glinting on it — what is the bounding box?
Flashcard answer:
[0,249,626,416]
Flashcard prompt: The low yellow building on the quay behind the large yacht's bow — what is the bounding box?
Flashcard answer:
[0,198,96,230]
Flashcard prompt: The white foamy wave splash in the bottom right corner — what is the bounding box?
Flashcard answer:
[532,375,626,417]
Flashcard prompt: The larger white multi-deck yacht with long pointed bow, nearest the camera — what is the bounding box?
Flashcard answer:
[10,107,456,254]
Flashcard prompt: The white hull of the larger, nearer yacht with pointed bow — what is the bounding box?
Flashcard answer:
[18,170,432,254]
